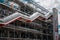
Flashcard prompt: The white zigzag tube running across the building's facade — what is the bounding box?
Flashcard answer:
[0,3,51,24]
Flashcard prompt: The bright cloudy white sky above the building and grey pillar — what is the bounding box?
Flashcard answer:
[35,0,60,9]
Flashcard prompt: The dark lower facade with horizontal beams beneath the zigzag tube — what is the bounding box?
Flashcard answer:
[0,21,53,40]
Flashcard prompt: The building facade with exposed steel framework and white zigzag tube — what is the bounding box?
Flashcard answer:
[0,0,58,40]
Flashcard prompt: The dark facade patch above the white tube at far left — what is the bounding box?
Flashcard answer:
[0,5,14,19]
